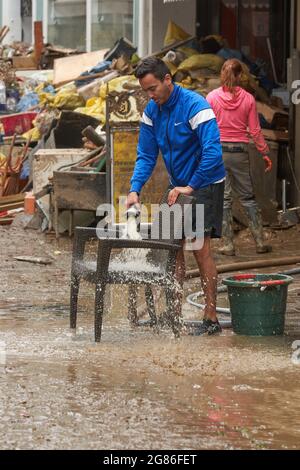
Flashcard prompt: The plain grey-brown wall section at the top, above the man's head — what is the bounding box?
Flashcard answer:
[152,0,196,52]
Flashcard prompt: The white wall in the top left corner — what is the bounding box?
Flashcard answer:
[2,0,22,44]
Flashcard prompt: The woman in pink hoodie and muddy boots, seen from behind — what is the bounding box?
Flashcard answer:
[207,59,272,256]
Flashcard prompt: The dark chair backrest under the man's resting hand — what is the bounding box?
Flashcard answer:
[151,190,195,243]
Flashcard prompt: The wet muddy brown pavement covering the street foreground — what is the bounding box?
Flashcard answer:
[0,224,300,450]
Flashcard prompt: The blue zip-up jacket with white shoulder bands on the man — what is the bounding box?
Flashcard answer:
[130,85,225,193]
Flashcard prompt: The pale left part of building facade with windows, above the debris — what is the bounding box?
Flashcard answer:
[0,0,197,56]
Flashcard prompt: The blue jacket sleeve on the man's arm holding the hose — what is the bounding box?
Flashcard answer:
[130,109,159,193]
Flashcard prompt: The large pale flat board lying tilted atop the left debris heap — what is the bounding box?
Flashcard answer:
[53,49,108,86]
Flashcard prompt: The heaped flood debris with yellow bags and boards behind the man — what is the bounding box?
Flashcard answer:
[0,22,288,229]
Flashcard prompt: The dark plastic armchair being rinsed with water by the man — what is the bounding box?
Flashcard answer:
[70,193,193,342]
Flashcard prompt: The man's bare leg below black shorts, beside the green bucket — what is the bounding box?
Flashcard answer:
[194,237,218,322]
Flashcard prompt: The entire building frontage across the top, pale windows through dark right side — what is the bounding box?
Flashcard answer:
[0,0,300,205]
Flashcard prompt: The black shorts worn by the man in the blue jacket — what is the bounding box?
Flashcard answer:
[193,182,225,238]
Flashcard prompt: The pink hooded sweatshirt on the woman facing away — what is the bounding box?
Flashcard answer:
[206,87,270,155]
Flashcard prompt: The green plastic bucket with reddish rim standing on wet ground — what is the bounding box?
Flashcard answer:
[223,274,293,336]
